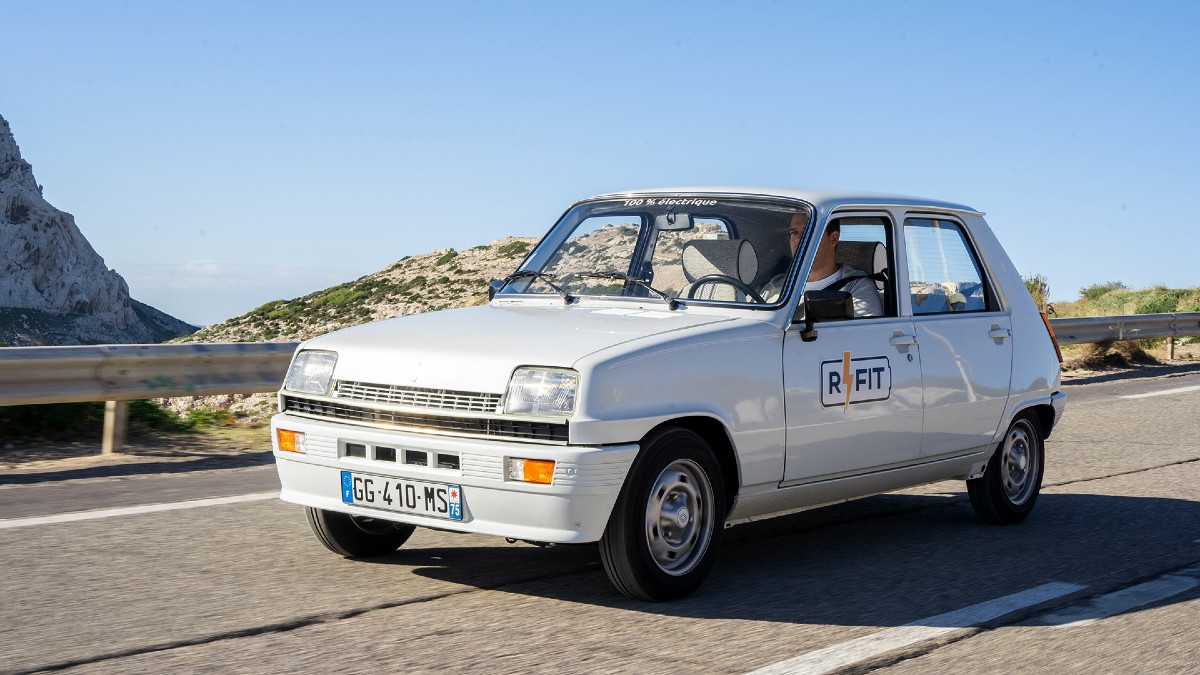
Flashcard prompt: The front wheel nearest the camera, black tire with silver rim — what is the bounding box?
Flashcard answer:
[600,428,725,601]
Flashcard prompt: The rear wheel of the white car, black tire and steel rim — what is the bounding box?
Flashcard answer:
[967,413,1045,525]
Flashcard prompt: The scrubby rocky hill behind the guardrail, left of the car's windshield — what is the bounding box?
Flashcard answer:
[176,237,536,342]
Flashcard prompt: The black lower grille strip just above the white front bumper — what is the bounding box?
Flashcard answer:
[283,396,568,443]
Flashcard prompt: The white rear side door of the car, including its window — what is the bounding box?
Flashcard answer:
[904,215,1013,459]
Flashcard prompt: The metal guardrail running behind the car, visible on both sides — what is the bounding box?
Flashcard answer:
[0,312,1200,453]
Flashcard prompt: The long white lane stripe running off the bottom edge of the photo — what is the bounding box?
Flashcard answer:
[750,581,1085,675]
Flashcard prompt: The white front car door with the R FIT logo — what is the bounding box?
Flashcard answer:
[784,214,922,485]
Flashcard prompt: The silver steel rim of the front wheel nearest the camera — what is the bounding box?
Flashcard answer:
[646,459,713,577]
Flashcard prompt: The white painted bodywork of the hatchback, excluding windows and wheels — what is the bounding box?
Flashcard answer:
[272,187,1064,543]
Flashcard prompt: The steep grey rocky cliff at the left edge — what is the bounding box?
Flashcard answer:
[0,117,196,346]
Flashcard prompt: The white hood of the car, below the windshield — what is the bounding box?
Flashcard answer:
[302,305,731,394]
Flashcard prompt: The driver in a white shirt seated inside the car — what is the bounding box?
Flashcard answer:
[761,214,883,318]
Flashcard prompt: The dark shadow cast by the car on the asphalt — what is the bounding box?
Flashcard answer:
[377,494,1200,626]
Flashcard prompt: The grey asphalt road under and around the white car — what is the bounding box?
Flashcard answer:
[0,368,1200,674]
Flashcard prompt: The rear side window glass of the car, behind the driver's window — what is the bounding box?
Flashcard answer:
[904,219,991,315]
